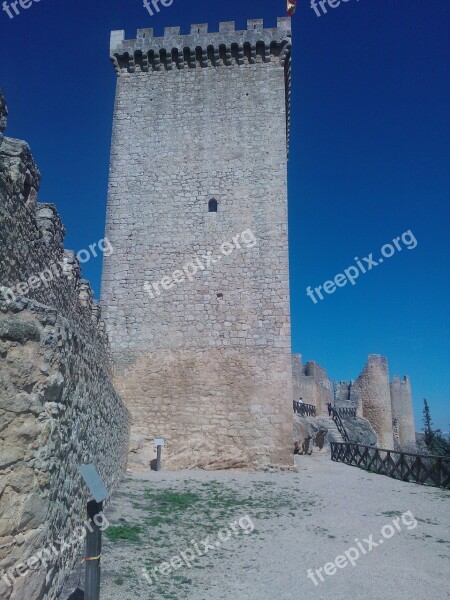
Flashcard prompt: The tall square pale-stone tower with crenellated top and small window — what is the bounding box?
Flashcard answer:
[102,18,293,468]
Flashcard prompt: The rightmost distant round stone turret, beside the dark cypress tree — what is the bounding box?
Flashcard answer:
[390,376,416,448]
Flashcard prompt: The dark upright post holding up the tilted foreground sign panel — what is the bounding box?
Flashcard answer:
[84,500,103,600]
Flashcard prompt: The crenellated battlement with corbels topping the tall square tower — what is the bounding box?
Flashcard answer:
[110,17,292,75]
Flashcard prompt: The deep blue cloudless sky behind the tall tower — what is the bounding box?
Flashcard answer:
[0,0,450,431]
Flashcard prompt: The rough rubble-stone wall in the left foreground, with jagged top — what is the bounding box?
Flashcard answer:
[0,93,129,600]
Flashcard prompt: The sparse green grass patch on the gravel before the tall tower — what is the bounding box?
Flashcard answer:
[108,479,318,600]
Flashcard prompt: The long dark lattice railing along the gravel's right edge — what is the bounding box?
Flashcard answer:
[331,442,450,489]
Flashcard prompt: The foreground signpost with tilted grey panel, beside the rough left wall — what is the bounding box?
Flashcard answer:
[78,465,109,600]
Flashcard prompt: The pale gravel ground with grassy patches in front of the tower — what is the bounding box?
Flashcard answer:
[61,454,450,600]
